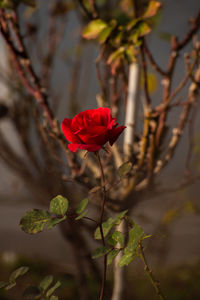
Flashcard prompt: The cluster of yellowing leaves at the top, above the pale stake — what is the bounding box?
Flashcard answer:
[82,1,161,64]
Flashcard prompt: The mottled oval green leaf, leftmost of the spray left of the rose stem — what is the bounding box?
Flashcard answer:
[19,209,51,234]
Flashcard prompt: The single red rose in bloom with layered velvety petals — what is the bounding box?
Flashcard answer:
[62,107,126,152]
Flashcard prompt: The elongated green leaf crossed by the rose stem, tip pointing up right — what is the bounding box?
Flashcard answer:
[94,210,128,240]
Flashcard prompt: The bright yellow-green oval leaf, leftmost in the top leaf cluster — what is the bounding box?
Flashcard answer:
[82,19,108,40]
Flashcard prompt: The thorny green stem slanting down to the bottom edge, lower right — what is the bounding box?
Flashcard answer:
[139,243,166,300]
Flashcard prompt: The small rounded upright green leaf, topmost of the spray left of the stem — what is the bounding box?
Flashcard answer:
[49,195,68,216]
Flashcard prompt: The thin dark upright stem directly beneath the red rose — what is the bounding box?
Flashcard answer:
[96,152,107,300]
